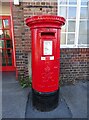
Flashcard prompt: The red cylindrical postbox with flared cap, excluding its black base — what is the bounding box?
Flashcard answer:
[26,15,65,92]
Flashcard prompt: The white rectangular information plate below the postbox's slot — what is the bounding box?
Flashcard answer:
[43,40,52,55]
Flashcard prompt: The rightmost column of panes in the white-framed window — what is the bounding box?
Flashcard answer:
[78,0,89,46]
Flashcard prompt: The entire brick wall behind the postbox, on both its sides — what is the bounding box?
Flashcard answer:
[13,0,89,84]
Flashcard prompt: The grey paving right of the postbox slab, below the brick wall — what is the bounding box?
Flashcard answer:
[60,81,87,118]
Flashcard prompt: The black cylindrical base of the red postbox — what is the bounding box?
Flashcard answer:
[32,89,59,112]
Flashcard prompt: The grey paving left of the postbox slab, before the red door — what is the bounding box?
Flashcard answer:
[2,72,29,118]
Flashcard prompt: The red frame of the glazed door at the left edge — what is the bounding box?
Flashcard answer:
[0,15,16,71]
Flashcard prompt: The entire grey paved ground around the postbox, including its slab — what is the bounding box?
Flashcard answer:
[0,72,87,118]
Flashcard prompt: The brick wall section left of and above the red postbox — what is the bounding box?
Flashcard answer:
[13,0,57,78]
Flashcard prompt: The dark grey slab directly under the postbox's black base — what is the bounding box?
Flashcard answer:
[25,91,72,118]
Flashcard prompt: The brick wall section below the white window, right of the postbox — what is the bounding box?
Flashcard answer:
[60,48,89,84]
